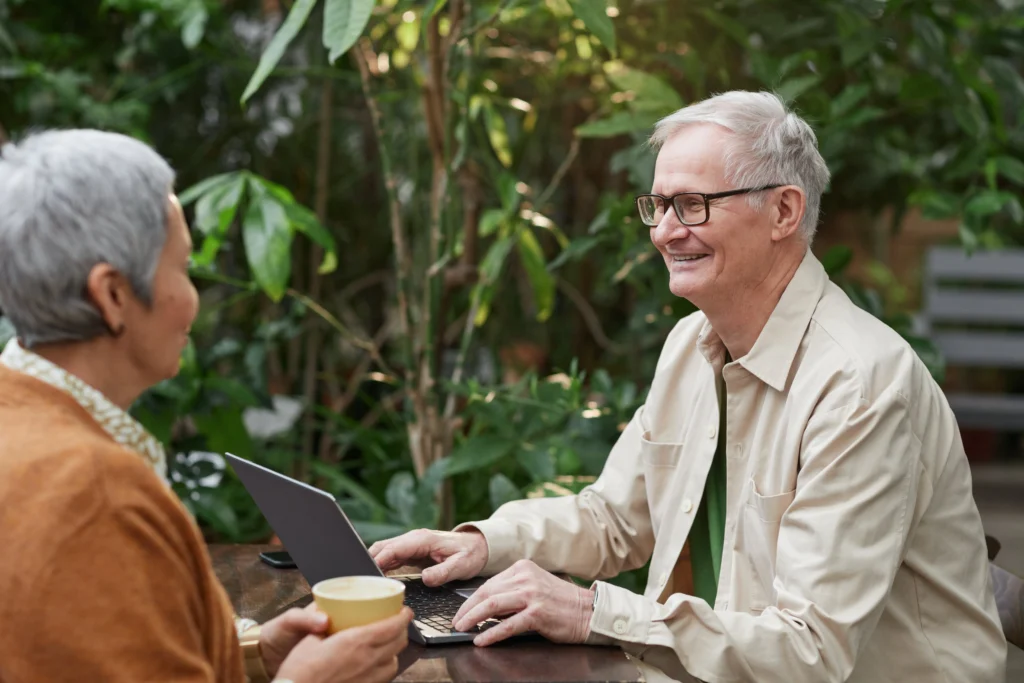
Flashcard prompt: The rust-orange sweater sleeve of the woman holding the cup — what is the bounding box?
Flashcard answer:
[5,464,230,683]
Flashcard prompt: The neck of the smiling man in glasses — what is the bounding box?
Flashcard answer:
[700,250,806,360]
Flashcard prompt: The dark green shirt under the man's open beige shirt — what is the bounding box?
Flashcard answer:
[689,354,729,607]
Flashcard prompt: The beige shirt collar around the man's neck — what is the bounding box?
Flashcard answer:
[697,249,828,391]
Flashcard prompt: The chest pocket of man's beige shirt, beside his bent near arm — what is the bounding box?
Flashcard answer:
[734,479,797,612]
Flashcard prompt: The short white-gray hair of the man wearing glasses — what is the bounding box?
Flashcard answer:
[650,90,829,244]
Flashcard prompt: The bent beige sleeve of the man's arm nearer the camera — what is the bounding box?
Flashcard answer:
[591,391,924,683]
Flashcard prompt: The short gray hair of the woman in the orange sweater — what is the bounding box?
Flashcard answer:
[0,130,174,347]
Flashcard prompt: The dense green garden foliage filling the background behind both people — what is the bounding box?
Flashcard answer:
[0,0,1024,583]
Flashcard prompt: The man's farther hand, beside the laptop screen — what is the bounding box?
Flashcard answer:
[370,528,487,586]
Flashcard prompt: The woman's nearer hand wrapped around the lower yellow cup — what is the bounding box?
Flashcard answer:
[276,607,413,683]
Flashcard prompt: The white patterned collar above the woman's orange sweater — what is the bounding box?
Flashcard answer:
[0,339,167,482]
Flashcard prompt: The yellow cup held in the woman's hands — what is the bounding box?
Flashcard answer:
[313,577,406,633]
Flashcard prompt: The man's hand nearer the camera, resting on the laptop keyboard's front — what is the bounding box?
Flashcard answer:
[453,560,594,647]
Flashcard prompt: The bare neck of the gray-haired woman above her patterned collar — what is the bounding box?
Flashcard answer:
[32,337,144,411]
